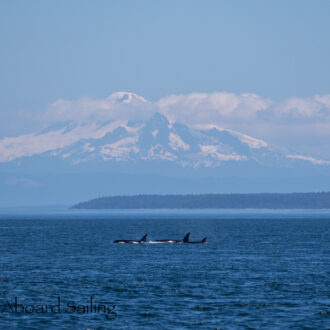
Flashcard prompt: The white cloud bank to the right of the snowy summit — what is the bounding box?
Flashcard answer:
[156,92,330,125]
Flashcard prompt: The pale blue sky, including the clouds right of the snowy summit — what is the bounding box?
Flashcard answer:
[0,0,330,156]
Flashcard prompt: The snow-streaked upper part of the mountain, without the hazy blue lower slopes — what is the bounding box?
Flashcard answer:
[0,111,330,168]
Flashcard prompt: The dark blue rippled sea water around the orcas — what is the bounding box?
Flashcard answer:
[0,209,330,329]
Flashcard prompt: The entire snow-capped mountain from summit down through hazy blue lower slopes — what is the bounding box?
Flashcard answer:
[0,107,330,206]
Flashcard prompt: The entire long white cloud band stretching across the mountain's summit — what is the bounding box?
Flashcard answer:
[43,92,330,135]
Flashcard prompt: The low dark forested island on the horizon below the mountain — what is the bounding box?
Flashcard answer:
[72,192,330,209]
